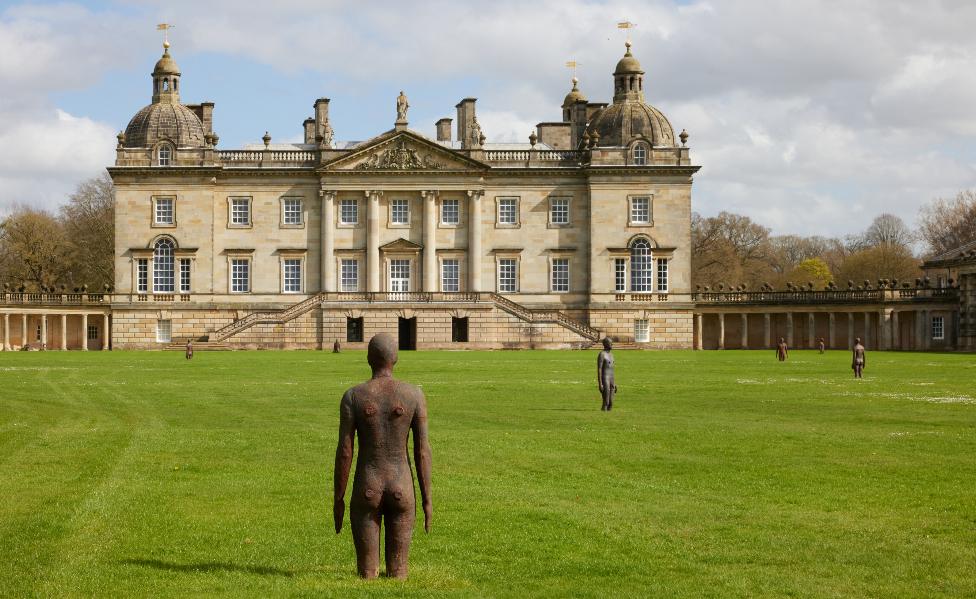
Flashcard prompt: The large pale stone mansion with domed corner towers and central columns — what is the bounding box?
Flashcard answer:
[108,43,699,348]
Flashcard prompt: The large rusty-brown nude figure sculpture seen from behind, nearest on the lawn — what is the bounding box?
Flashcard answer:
[333,333,433,578]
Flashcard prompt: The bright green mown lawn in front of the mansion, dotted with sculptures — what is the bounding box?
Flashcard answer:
[0,351,976,597]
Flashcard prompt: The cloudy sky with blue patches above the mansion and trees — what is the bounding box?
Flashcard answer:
[0,0,976,236]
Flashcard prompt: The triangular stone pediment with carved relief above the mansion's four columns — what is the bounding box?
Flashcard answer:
[324,131,487,172]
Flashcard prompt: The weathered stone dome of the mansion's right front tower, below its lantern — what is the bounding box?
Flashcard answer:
[586,101,675,147]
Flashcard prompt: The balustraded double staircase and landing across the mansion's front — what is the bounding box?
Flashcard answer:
[206,292,603,349]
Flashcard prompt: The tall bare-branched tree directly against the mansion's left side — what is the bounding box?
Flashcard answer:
[60,174,115,289]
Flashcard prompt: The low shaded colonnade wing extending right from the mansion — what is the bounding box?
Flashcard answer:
[695,306,951,350]
